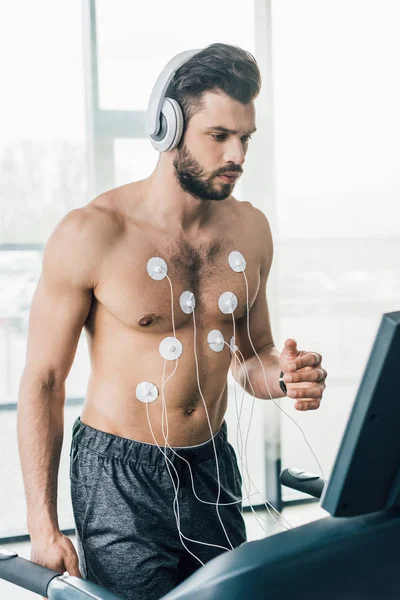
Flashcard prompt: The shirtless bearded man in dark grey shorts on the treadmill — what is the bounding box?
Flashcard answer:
[18,44,326,600]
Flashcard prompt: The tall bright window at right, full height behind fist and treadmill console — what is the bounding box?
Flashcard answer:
[273,0,400,497]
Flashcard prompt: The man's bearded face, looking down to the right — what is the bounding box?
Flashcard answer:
[173,92,255,200]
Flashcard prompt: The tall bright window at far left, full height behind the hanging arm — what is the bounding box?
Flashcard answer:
[0,0,87,537]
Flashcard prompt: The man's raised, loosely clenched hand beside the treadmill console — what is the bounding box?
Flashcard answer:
[279,339,327,410]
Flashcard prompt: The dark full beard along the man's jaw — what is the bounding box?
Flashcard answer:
[173,144,238,200]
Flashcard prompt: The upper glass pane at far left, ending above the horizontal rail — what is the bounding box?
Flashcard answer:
[0,0,87,244]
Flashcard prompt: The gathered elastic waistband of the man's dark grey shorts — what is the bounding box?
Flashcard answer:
[72,417,228,464]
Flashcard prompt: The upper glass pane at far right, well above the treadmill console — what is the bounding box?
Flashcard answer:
[273,0,400,238]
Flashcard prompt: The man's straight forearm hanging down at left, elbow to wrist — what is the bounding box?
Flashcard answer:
[17,376,65,538]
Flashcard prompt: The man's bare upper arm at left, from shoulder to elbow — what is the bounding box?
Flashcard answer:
[24,210,95,385]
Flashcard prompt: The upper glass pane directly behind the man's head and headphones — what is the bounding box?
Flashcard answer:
[96,0,254,110]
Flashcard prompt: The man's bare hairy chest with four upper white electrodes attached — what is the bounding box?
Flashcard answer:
[95,226,261,333]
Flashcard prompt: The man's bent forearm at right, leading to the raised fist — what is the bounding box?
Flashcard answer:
[231,346,285,400]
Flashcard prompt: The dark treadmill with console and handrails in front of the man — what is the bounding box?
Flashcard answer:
[0,311,400,600]
